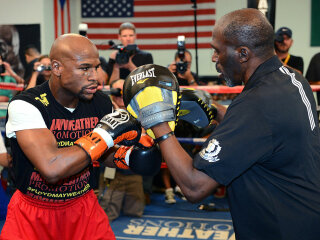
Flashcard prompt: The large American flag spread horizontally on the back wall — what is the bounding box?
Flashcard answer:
[81,0,215,50]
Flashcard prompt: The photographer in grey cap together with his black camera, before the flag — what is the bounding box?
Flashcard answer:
[109,22,153,84]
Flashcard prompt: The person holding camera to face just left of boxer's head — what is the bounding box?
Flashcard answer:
[26,55,51,89]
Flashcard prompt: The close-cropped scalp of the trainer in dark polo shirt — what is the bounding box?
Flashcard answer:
[214,8,274,57]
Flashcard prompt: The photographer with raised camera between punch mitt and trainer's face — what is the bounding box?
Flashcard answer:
[168,50,198,86]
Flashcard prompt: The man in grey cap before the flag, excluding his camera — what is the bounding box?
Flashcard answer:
[109,22,153,84]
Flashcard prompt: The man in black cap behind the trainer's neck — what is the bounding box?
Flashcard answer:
[274,27,303,74]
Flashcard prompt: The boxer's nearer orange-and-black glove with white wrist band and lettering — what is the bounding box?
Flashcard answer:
[75,109,141,165]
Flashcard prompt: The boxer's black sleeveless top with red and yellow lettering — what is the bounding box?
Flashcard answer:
[10,81,112,202]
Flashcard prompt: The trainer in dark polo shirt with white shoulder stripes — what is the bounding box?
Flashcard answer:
[124,9,320,240]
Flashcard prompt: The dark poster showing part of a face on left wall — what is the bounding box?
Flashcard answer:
[0,24,41,76]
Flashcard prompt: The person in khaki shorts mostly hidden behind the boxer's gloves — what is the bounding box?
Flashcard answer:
[100,79,145,221]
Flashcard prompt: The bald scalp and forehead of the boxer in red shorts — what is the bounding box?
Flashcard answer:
[50,34,99,61]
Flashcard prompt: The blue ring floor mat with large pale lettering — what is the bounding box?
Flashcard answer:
[111,193,234,240]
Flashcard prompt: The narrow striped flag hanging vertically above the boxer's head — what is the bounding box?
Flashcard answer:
[53,0,71,38]
